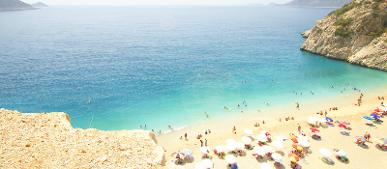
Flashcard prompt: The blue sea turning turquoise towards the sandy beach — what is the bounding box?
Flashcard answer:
[0,6,387,130]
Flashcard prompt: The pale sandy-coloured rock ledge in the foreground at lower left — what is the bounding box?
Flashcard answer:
[0,109,164,169]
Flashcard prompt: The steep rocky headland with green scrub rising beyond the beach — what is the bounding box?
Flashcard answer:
[301,0,387,71]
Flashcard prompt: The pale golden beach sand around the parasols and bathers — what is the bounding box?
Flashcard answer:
[157,86,387,169]
